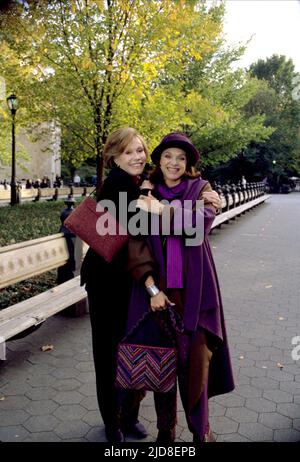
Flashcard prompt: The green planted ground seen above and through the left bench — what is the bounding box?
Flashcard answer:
[0,200,81,309]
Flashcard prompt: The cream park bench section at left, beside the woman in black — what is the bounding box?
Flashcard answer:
[0,233,87,360]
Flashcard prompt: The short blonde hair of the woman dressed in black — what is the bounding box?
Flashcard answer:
[103,127,148,168]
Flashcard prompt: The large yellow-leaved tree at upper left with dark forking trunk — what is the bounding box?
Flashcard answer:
[1,0,224,184]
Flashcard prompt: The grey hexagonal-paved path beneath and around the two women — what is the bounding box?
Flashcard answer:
[0,193,300,442]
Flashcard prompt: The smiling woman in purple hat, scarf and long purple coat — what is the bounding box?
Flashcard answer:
[127,133,234,443]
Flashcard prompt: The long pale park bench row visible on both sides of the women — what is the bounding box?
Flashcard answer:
[0,183,270,360]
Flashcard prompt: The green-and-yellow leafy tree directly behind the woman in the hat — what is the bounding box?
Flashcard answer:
[111,4,273,169]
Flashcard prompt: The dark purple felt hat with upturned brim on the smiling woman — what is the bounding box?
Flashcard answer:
[151,132,200,165]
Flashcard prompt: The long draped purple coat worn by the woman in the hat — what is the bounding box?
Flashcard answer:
[127,178,234,434]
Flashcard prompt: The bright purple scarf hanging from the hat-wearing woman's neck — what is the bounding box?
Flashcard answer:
[156,180,187,289]
